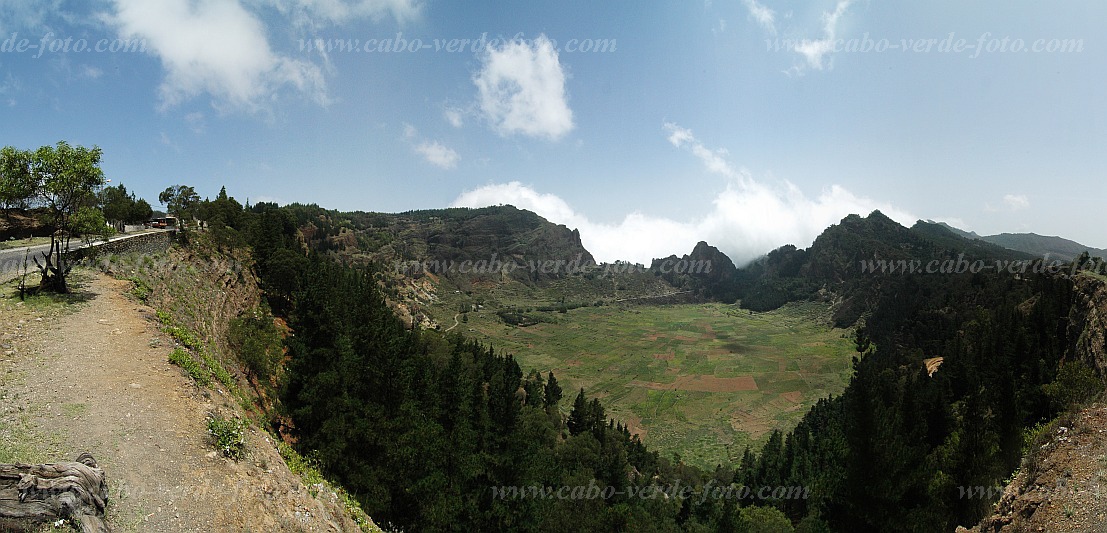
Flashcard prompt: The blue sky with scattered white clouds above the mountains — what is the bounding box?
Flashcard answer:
[0,0,1107,264]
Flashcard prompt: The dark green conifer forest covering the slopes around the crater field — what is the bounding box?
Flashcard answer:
[211,197,1101,531]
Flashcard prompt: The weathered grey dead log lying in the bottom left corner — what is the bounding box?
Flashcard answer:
[0,452,108,533]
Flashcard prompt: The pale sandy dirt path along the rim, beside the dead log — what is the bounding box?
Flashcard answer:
[0,275,355,531]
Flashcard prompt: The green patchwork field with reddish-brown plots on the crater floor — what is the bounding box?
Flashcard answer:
[434,298,856,468]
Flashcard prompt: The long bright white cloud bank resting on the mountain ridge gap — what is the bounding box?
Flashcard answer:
[453,122,918,265]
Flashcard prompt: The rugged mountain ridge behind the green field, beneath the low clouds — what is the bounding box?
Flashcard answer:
[290,205,1107,326]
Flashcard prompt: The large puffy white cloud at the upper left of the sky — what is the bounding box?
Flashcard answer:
[107,0,328,112]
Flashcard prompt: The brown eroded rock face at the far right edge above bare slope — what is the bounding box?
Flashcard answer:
[1068,273,1107,377]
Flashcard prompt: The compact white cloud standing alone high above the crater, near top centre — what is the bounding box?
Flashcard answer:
[473,34,573,141]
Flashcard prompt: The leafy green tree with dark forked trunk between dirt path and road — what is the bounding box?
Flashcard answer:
[30,141,104,293]
